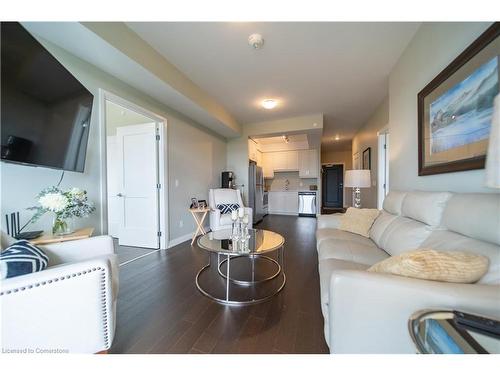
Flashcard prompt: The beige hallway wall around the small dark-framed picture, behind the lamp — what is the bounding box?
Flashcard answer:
[352,98,389,208]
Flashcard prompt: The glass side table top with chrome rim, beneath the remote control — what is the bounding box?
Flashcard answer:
[408,310,500,354]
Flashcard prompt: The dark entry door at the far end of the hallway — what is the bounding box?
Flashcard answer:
[321,164,344,214]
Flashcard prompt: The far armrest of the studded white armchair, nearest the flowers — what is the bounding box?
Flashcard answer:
[39,236,115,265]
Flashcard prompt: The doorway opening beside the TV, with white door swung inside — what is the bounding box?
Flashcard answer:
[101,93,168,265]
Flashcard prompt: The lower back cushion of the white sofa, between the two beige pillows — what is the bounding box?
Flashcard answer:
[379,216,432,255]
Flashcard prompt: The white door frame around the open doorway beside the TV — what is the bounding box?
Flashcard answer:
[98,89,169,250]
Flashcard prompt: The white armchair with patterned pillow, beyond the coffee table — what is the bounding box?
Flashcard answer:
[208,189,252,231]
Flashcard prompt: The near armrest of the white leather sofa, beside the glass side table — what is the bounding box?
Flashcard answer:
[329,270,500,353]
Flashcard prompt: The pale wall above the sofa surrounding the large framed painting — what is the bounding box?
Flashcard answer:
[386,22,494,192]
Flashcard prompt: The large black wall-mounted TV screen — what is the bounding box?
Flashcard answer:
[0,22,94,172]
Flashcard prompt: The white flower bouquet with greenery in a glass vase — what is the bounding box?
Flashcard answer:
[28,186,95,233]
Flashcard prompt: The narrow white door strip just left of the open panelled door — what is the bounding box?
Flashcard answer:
[106,135,121,238]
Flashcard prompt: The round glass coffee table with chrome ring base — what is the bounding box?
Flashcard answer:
[196,229,286,306]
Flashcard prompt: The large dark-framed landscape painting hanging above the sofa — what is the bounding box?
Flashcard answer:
[417,22,500,176]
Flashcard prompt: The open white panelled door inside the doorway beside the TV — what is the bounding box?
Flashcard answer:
[116,123,159,249]
